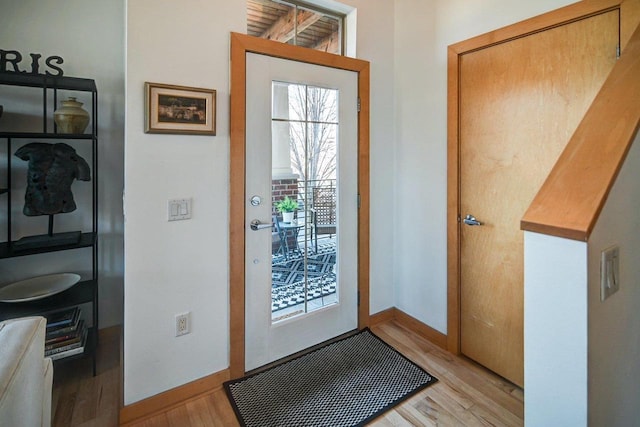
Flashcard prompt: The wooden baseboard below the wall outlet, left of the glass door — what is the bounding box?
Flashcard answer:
[120,369,230,426]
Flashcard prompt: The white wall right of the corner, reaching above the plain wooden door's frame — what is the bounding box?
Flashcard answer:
[394,0,573,333]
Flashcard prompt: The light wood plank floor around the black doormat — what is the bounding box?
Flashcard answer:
[52,321,524,427]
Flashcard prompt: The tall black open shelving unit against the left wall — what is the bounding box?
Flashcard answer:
[0,72,99,376]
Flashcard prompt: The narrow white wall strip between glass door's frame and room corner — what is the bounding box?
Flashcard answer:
[343,0,396,314]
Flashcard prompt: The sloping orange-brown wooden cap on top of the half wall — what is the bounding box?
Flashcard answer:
[520,21,640,241]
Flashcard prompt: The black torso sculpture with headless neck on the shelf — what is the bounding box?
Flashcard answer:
[15,142,91,216]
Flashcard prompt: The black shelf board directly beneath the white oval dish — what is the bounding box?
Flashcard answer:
[0,280,98,321]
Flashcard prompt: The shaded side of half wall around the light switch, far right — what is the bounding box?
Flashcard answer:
[588,134,640,427]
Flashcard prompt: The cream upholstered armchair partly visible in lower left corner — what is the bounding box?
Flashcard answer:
[0,317,53,427]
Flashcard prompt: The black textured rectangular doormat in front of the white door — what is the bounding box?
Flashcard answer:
[224,329,437,427]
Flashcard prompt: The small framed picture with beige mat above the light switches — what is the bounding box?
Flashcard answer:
[144,82,216,135]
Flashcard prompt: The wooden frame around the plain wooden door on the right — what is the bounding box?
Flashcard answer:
[447,0,638,354]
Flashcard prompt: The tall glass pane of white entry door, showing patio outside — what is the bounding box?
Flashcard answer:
[271,82,339,322]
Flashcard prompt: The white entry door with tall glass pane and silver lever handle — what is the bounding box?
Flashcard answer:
[245,53,358,370]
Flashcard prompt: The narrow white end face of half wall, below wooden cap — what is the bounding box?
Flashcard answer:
[524,232,588,427]
